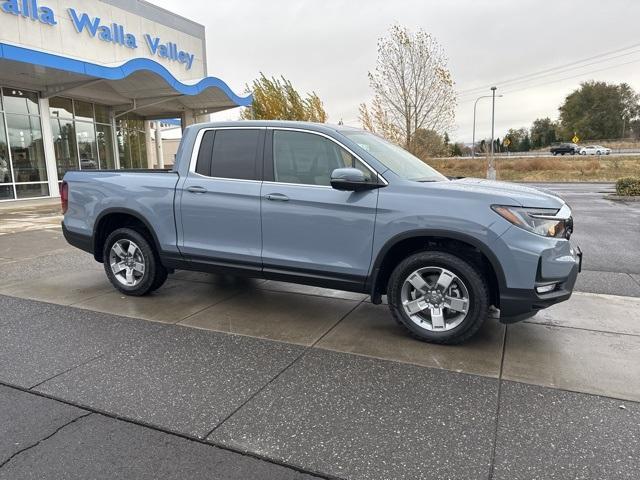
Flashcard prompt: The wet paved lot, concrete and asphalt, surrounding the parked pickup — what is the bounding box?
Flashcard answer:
[0,184,640,480]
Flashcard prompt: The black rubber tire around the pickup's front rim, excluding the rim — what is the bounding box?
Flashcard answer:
[387,251,489,345]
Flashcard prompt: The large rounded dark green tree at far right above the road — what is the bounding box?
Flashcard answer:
[559,81,640,140]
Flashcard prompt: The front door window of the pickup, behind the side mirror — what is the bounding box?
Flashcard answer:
[273,130,372,185]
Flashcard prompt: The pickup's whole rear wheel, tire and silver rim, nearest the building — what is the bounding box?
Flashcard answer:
[102,228,167,296]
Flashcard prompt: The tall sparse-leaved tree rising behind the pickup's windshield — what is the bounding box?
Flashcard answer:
[360,25,456,151]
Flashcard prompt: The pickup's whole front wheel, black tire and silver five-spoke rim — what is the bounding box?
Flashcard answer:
[387,251,489,344]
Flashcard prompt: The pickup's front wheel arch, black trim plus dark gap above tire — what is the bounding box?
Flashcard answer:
[367,229,506,305]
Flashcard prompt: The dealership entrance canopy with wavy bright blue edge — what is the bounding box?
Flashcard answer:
[0,43,252,118]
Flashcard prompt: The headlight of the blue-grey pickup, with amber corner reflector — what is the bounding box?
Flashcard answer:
[491,204,573,238]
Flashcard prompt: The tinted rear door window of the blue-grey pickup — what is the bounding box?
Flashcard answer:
[196,129,263,180]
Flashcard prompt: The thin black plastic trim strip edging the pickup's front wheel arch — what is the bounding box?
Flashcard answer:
[366,229,507,299]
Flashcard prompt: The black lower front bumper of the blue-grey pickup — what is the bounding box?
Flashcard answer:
[500,246,582,323]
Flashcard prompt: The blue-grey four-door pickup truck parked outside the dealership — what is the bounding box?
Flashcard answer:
[61,121,582,344]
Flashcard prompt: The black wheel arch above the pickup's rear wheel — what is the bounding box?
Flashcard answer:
[92,208,160,262]
